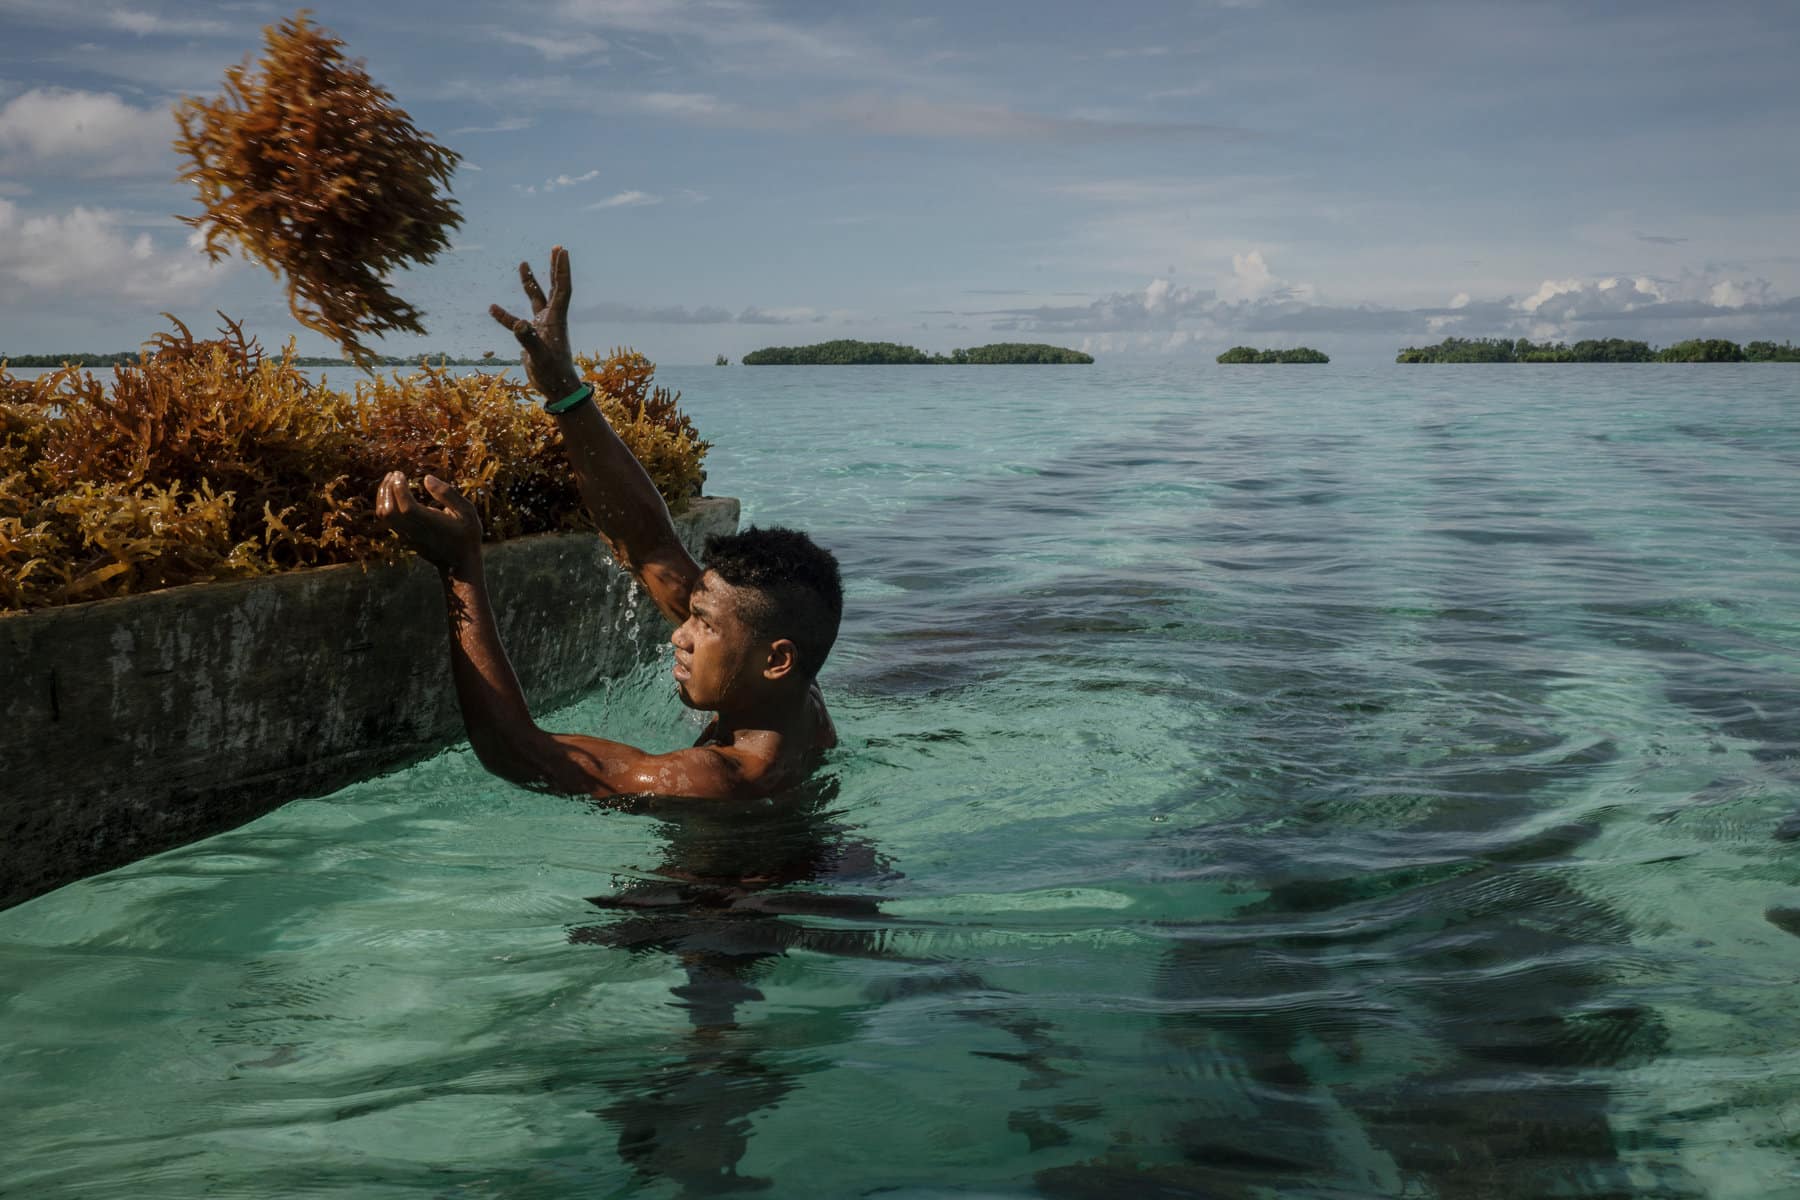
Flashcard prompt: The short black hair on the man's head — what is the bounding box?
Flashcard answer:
[706,525,844,680]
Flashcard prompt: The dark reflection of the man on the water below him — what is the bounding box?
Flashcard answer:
[569,777,921,1195]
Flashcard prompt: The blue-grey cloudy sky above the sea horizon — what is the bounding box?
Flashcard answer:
[0,0,1800,363]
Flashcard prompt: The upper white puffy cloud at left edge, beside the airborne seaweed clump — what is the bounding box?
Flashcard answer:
[0,88,176,176]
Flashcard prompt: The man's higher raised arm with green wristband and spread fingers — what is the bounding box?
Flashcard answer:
[488,246,700,624]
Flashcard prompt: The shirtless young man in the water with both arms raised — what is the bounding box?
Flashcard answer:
[374,246,844,801]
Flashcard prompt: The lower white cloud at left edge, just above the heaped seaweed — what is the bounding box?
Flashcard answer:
[0,200,230,308]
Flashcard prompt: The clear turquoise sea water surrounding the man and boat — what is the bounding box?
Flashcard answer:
[0,365,1800,1198]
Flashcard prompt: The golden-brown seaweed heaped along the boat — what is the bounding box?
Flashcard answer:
[0,318,711,613]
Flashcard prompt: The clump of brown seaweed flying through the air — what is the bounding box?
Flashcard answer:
[175,9,463,367]
